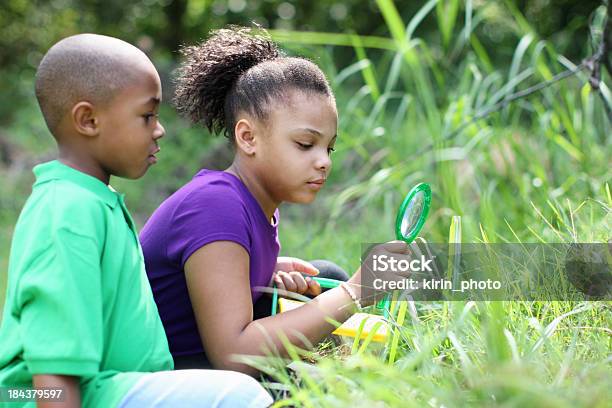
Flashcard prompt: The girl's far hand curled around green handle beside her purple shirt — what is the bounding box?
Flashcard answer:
[272,256,321,296]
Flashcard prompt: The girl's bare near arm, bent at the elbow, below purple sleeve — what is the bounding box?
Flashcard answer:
[185,241,359,375]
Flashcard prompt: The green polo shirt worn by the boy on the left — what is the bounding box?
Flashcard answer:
[0,161,173,408]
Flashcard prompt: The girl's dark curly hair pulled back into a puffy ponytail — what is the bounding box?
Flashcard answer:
[174,26,333,139]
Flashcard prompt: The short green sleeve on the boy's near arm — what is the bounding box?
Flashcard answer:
[16,228,103,376]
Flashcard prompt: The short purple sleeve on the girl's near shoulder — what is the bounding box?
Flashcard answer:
[167,183,252,268]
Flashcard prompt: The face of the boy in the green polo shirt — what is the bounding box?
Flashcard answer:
[94,63,165,179]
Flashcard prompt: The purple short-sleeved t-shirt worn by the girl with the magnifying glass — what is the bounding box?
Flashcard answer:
[140,170,280,356]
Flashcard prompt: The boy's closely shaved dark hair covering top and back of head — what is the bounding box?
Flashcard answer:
[36,34,152,139]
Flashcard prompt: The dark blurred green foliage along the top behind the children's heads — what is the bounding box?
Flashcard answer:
[0,0,600,125]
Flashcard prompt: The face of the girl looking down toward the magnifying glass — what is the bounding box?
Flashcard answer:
[255,91,338,204]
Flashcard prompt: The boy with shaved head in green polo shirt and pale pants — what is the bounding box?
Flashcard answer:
[0,34,272,407]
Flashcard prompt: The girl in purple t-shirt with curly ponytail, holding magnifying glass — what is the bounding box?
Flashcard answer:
[140,28,402,374]
